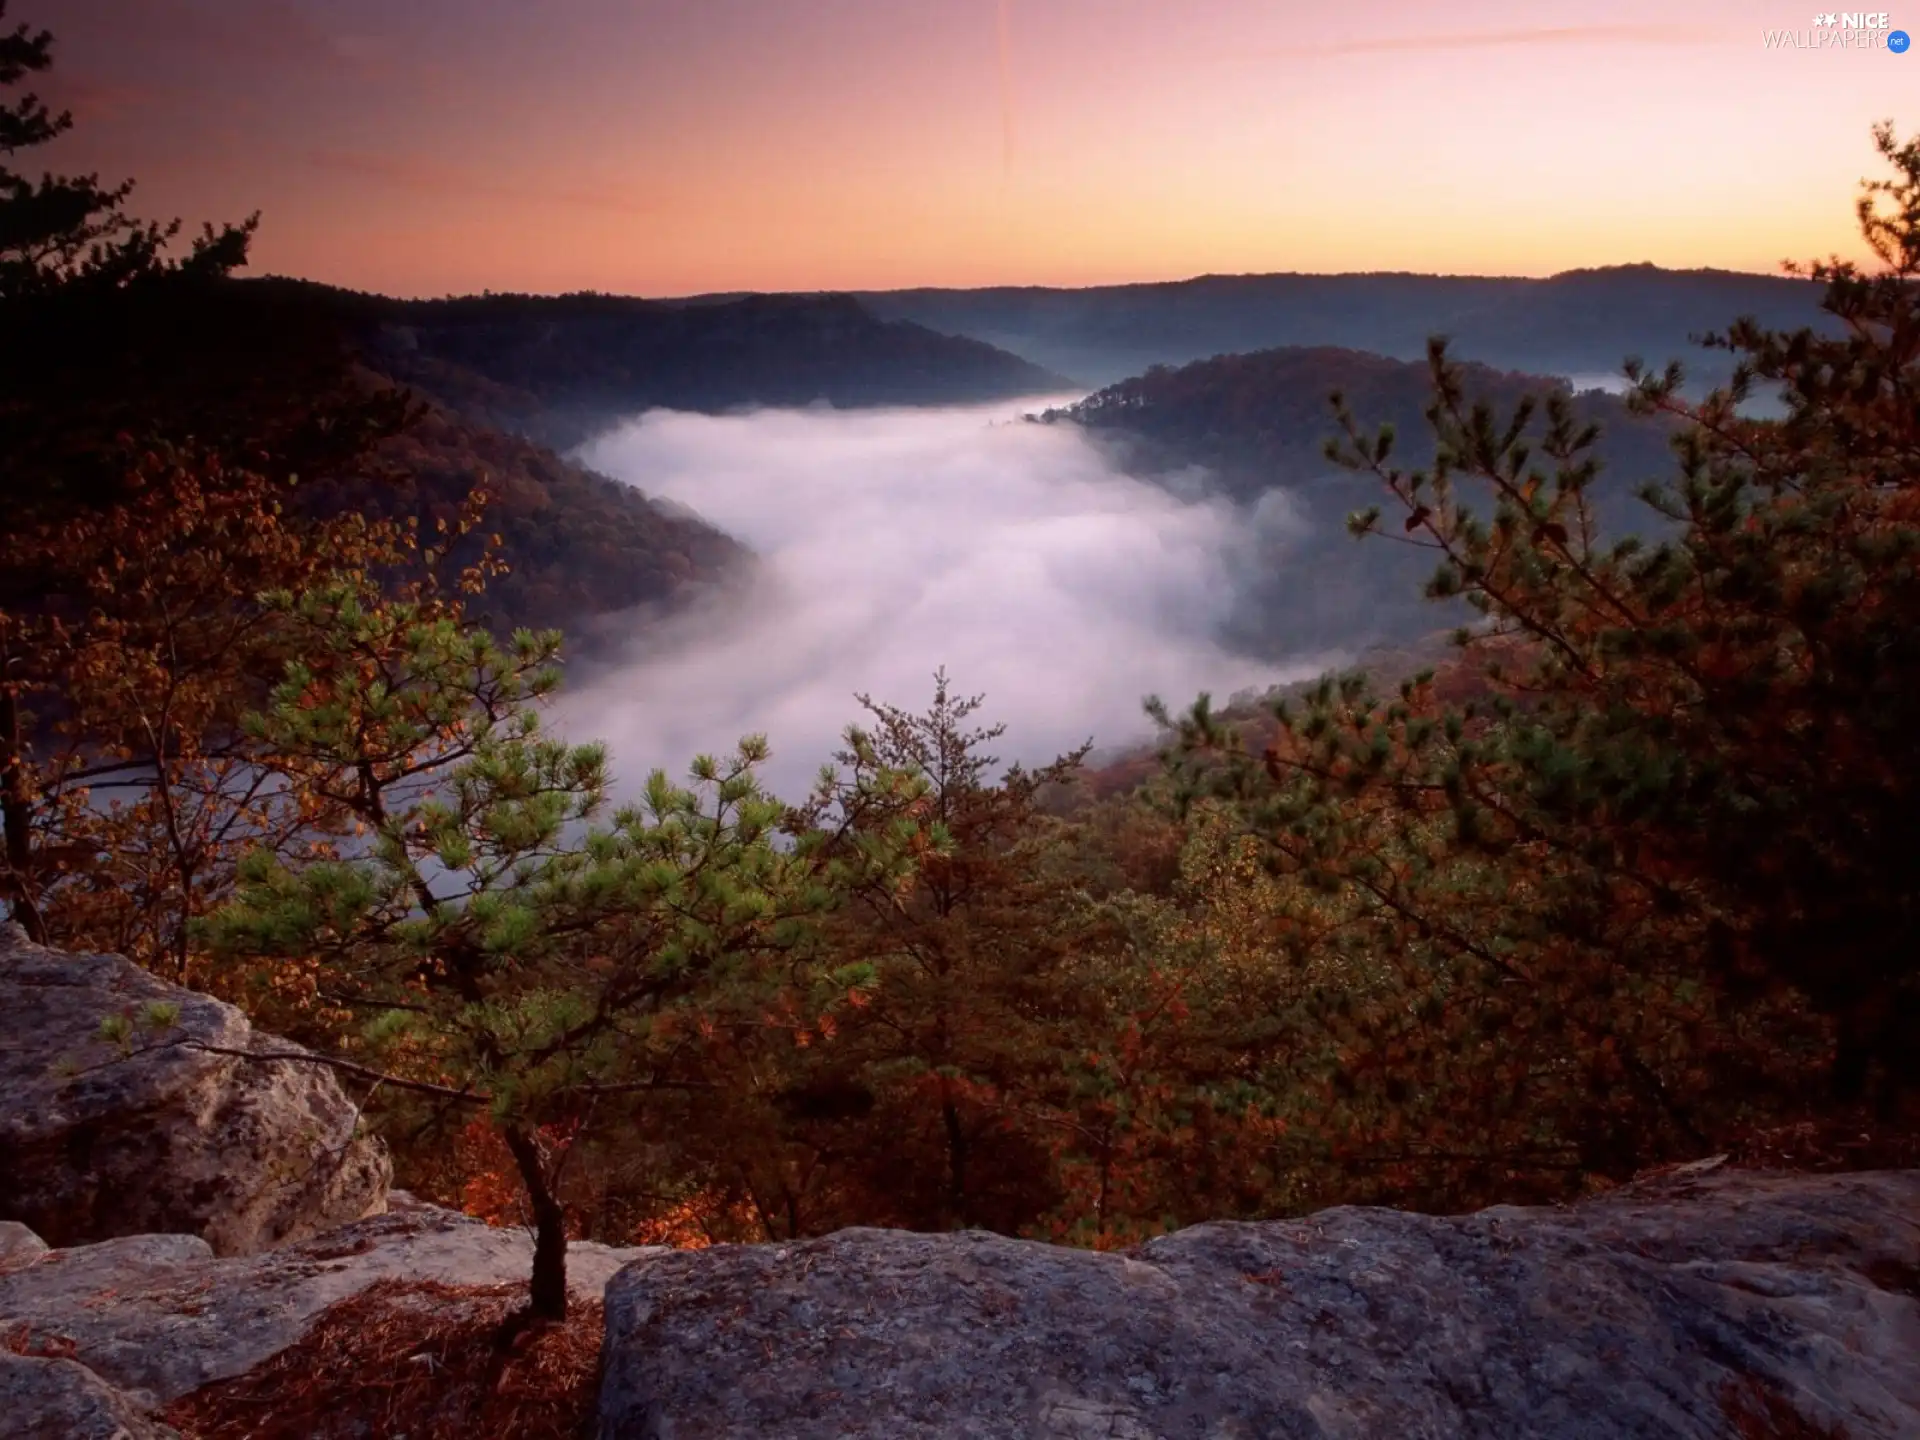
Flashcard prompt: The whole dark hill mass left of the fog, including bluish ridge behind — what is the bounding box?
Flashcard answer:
[11,280,1066,639]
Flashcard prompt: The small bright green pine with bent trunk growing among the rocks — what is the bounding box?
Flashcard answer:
[207,584,921,1319]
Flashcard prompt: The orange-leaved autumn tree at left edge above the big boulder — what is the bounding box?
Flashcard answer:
[0,453,435,975]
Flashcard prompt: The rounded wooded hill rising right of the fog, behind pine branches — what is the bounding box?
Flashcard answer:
[1031,346,1672,655]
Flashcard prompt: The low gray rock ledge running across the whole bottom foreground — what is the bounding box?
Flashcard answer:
[11,1169,1920,1440]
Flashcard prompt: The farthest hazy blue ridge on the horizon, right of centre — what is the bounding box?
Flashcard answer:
[860,265,1822,384]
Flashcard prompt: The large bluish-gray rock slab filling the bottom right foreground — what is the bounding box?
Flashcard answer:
[599,1169,1920,1440]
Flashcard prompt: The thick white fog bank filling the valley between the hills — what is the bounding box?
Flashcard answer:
[559,401,1329,799]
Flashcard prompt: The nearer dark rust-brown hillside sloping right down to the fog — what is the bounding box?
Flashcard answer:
[0,276,745,637]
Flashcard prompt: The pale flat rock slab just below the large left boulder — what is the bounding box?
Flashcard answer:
[0,1206,664,1413]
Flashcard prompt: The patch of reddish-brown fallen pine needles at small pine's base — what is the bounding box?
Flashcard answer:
[165,1281,601,1440]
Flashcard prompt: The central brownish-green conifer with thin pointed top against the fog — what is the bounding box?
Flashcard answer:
[729,672,1085,1229]
